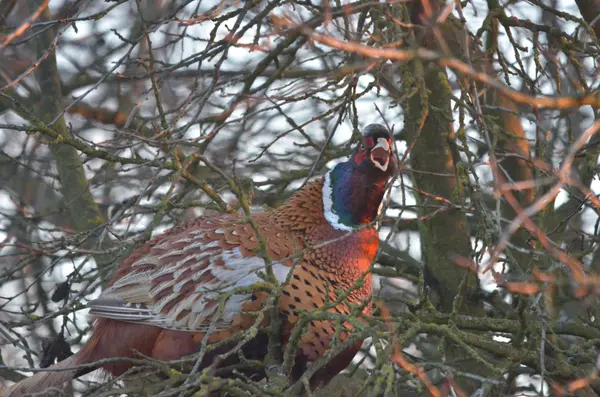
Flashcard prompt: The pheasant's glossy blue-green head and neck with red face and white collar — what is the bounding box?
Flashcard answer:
[323,124,396,230]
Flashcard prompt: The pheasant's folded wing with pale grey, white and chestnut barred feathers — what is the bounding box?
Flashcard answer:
[89,213,301,332]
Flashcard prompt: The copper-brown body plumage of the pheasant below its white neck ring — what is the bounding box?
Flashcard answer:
[12,179,378,395]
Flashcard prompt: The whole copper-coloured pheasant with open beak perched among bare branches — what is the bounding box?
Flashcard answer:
[10,124,397,396]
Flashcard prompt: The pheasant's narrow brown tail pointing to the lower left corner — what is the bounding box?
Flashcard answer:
[2,354,80,397]
